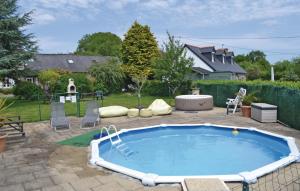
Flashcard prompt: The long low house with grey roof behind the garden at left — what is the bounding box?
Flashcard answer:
[0,54,111,88]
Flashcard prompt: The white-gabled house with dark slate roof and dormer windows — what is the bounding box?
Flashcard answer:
[184,44,246,80]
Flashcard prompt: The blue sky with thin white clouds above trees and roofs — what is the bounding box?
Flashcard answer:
[18,0,300,63]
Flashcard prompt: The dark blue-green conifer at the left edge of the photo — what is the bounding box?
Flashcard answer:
[0,0,37,78]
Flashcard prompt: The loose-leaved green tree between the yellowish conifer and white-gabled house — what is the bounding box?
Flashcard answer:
[154,33,193,96]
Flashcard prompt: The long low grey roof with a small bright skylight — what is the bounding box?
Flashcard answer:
[26,54,111,72]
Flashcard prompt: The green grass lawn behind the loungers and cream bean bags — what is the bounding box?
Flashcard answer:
[7,94,174,122]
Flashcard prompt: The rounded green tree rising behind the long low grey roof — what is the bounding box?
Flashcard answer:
[75,32,122,57]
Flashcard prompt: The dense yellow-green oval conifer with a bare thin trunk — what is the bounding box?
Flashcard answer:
[122,21,159,107]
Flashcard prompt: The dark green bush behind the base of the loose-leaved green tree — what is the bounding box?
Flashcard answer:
[143,80,192,96]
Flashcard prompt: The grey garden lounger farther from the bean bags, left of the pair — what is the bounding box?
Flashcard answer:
[50,102,71,131]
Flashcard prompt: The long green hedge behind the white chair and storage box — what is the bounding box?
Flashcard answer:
[196,81,300,130]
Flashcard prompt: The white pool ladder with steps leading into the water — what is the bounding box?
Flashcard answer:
[100,125,134,158]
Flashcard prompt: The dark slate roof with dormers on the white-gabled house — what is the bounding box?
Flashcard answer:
[185,44,246,74]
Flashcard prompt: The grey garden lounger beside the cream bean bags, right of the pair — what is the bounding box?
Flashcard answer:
[80,101,100,128]
